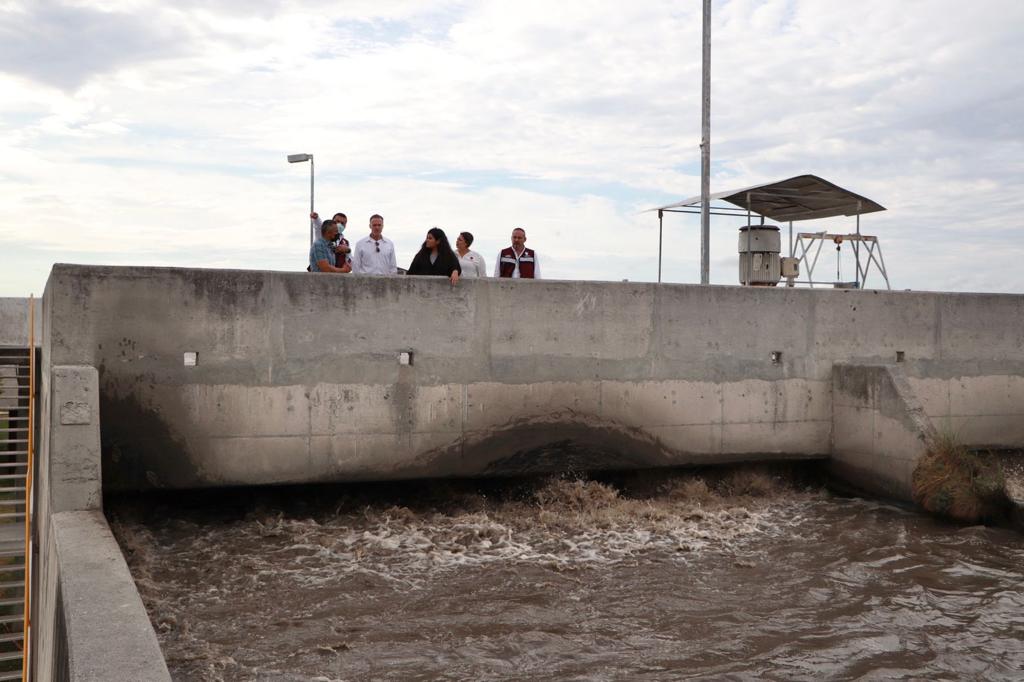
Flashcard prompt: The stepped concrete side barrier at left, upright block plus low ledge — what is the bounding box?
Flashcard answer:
[31,366,170,682]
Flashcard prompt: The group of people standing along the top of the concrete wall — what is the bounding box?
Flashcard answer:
[307,206,541,285]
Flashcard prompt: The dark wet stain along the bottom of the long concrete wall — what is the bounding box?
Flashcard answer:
[100,379,820,485]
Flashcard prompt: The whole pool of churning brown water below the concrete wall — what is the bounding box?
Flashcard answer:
[109,472,1024,680]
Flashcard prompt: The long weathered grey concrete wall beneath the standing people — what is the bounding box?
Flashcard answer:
[37,265,1024,492]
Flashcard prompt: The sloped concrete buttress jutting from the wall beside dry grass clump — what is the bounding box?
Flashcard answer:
[830,365,935,501]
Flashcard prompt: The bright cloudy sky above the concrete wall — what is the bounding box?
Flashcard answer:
[0,0,1024,296]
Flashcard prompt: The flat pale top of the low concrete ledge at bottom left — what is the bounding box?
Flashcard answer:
[51,511,171,682]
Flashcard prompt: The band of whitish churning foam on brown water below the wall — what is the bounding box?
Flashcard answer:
[121,481,815,589]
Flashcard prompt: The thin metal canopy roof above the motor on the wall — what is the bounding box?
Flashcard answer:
[650,175,886,222]
